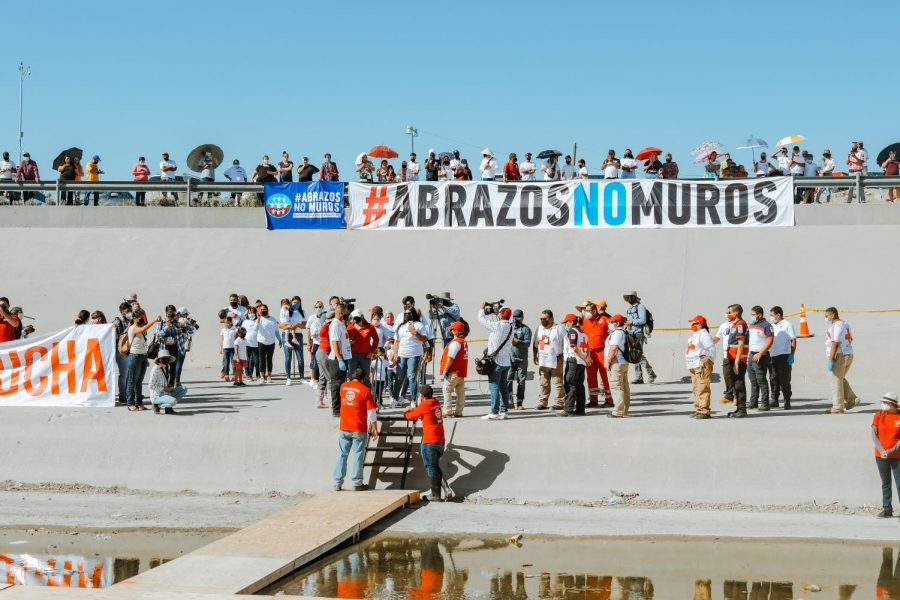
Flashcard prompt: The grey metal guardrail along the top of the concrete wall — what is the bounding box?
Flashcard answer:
[0,175,900,206]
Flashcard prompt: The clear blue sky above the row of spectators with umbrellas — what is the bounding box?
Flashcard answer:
[0,0,900,179]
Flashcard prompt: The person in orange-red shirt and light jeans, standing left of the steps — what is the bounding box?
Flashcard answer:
[334,369,378,492]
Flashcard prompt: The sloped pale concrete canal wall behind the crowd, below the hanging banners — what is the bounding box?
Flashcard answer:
[0,205,900,386]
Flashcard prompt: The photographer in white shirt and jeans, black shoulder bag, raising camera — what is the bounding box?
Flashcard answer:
[476,300,513,421]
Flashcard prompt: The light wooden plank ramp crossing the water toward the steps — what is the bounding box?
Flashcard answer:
[0,490,419,600]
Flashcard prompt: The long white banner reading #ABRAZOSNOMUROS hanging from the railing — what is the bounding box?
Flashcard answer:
[347,177,794,230]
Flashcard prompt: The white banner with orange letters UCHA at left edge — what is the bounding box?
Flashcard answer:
[0,325,116,406]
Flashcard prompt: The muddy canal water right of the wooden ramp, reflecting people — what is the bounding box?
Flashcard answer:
[262,536,900,600]
